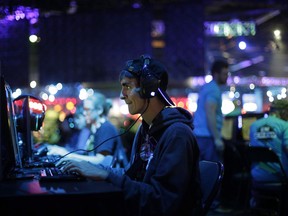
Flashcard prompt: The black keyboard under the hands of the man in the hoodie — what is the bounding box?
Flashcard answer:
[39,167,85,181]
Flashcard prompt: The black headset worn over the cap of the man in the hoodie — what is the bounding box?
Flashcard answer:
[138,55,160,98]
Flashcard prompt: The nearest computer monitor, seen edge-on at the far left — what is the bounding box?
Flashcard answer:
[0,75,22,181]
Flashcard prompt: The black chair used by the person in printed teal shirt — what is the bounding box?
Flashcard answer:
[248,146,288,216]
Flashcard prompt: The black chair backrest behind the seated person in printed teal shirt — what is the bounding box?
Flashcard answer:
[248,146,287,180]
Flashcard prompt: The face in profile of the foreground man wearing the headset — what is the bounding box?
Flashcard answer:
[120,77,147,115]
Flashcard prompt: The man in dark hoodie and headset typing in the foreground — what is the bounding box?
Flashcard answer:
[60,55,201,216]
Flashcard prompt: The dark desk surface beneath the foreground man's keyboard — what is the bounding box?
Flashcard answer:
[0,180,125,216]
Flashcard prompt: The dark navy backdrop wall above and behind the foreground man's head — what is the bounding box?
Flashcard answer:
[0,3,204,86]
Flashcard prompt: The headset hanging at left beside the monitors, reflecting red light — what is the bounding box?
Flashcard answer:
[13,94,45,132]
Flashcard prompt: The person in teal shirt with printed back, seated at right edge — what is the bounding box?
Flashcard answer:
[249,99,288,215]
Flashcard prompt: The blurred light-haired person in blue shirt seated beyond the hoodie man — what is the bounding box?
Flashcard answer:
[48,92,122,164]
